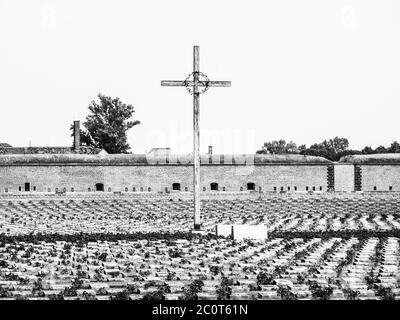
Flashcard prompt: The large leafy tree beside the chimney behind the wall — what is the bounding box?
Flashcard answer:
[71,93,140,153]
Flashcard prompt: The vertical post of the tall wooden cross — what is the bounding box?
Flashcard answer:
[193,46,200,230]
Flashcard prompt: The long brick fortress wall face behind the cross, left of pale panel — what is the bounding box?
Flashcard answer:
[0,164,327,193]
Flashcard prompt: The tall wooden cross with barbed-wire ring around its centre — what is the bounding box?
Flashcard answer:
[161,46,231,230]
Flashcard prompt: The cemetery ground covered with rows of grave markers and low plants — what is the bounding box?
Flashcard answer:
[0,193,400,300]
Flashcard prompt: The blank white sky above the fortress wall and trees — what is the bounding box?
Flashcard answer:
[0,0,400,153]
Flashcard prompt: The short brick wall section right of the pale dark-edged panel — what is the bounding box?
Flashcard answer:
[361,164,400,191]
